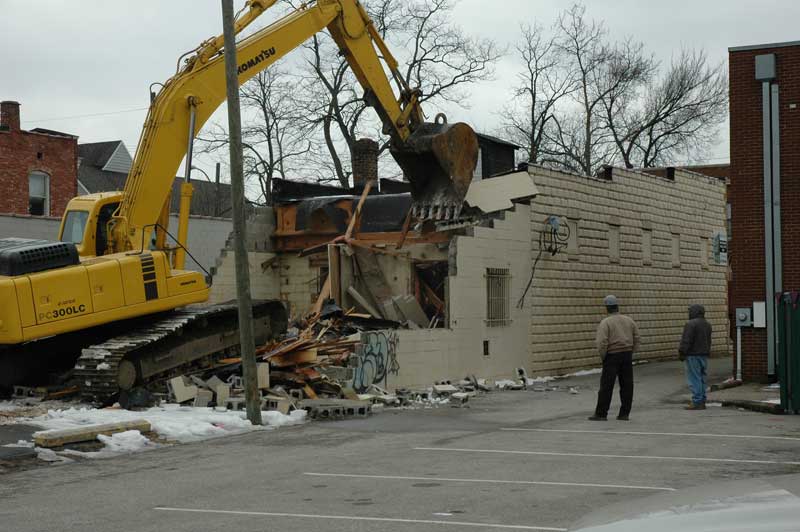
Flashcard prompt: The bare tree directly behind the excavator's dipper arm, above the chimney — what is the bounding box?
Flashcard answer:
[292,0,501,187]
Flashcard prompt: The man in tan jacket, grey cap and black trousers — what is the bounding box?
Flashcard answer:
[589,295,640,421]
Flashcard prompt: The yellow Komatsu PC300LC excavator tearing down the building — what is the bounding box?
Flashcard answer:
[0,0,478,402]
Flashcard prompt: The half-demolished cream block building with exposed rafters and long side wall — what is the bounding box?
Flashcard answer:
[211,161,729,391]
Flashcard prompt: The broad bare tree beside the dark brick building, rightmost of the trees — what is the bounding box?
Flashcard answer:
[603,50,728,168]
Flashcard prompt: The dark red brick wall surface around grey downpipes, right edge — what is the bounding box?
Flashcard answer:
[729,46,800,381]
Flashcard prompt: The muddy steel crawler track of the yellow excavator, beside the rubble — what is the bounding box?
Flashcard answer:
[74,301,287,404]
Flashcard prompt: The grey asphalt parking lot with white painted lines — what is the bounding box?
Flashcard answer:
[0,360,800,532]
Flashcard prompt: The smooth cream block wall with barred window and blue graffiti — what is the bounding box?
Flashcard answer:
[386,205,530,388]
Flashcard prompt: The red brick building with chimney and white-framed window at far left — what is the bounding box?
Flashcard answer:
[0,101,78,217]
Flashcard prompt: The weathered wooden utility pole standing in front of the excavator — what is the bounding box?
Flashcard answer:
[222,0,261,425]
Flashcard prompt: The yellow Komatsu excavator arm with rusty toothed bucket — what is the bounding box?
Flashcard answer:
[110,0,478,260]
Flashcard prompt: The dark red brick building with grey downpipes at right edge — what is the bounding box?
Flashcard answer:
[729,42,800,381]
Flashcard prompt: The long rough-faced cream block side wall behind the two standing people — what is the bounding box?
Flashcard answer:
[529,167,729,374]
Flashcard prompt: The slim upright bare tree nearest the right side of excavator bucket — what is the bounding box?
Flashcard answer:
[500,25,578,164]
